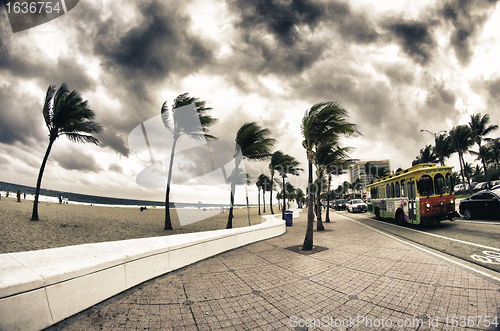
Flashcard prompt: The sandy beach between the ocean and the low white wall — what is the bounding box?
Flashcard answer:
[0,196,279,254]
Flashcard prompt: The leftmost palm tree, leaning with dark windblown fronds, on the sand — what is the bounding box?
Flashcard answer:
[31,83,101,221]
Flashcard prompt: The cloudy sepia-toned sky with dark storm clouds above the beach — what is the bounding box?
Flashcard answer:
[0,0,500,203]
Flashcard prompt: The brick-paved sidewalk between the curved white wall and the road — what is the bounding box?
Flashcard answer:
[49,212,500,330]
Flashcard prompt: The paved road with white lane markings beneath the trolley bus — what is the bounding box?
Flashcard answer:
[337,211,500,272]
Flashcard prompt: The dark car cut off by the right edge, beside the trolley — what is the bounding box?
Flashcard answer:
[459,189,500,220]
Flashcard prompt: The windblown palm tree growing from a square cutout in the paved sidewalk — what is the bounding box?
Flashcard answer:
[301,102,360,250]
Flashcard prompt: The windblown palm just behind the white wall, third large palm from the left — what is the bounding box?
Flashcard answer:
[226,122,275,229]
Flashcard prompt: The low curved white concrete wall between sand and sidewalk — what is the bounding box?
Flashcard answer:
[0,212,292,331]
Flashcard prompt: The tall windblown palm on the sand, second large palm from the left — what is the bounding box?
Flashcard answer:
[161,93,217,230]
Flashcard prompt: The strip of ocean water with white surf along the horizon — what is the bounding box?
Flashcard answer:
[0,182,234,209]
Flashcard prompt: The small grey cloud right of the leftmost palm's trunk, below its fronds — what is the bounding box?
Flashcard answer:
[50,145,103,173]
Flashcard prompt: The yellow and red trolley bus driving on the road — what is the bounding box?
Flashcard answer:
[366,163,459,225]
